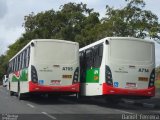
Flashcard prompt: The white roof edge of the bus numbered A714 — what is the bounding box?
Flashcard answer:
[79,37,154,51]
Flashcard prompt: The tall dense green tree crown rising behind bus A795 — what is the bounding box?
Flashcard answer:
[23,3,100,46]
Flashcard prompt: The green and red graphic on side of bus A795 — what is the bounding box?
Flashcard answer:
[12,68,28,82]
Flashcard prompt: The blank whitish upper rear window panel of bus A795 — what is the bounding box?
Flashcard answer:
[34,42,78,64]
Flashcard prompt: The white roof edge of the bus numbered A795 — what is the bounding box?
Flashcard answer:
[9,39,79,61]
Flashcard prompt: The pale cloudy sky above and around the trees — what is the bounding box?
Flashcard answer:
[0,0,160,65]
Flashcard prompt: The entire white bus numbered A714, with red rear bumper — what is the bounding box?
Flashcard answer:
[79,37,155,102]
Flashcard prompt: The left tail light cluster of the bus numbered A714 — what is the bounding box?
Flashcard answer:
[105,65,113,85]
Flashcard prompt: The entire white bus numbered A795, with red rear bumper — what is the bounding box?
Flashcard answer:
[8,39,80,99]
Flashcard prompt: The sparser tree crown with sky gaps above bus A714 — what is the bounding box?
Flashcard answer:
[102,0,160,39]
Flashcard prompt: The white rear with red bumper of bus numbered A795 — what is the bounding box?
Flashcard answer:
[29,41,79,93]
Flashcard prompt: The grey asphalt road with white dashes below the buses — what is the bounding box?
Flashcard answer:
[0,87,160,120]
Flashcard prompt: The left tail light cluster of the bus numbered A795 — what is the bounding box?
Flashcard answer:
[31,65,38,83]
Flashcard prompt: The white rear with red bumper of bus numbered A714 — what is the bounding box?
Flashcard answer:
[103,39,155,97]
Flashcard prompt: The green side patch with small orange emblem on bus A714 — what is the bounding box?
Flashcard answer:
[86,68,99,83]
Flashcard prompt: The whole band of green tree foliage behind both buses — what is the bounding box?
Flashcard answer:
[0,0,160,80]
